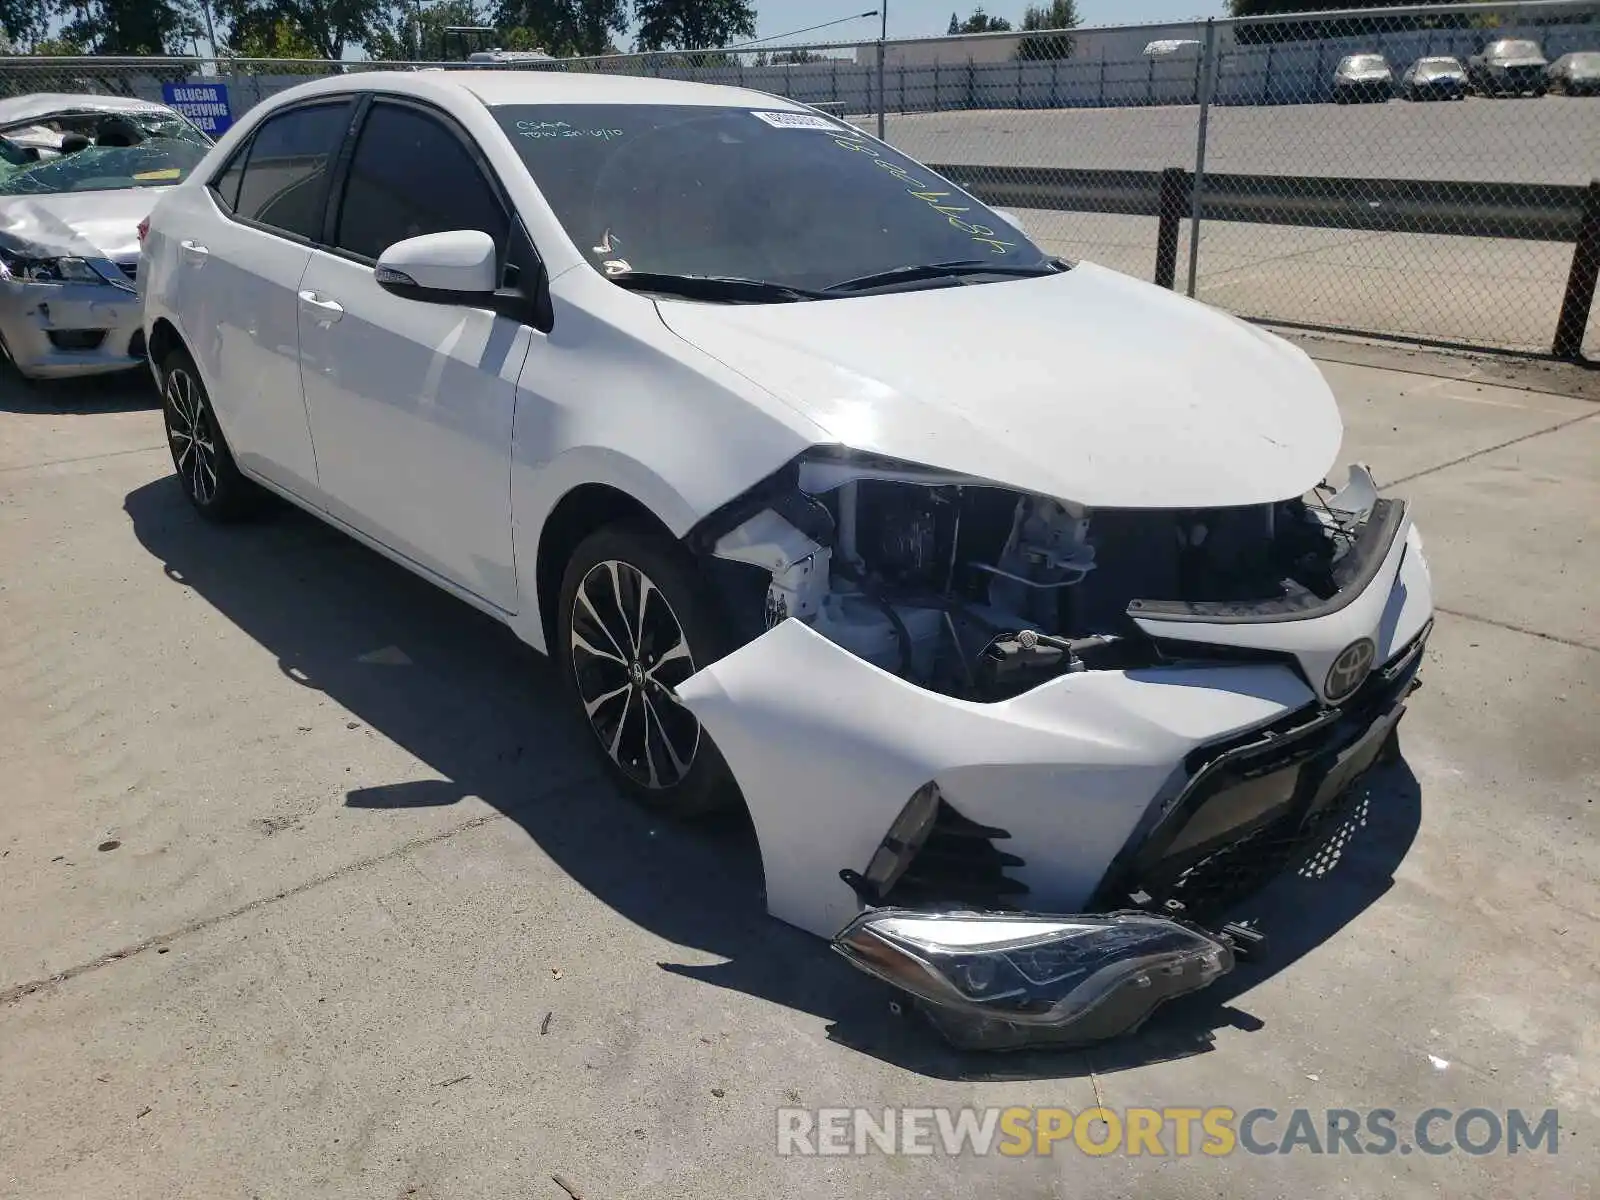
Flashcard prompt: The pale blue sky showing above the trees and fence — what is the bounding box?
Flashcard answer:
[755,0,1227,42]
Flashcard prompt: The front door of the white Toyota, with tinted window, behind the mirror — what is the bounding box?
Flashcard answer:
[298,98,531,613]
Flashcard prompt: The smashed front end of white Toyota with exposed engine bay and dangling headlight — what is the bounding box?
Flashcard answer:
[678,448,1432,1050]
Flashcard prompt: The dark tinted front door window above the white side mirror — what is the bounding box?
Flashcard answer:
[334,102,510,259]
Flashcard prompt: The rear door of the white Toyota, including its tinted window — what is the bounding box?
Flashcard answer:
[174,98,354,501]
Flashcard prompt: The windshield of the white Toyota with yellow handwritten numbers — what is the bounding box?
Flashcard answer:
[494,104,1053,288]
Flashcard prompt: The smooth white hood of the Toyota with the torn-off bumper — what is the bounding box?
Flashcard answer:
[658,264,1342,507]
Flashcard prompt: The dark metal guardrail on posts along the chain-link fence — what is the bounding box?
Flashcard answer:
[930,163,1600,358]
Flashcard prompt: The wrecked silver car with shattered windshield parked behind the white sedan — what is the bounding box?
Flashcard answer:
[0,94,211,379]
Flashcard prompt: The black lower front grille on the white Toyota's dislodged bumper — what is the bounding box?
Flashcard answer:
[1098,629,1429,920]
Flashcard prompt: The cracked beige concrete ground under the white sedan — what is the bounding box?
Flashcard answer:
[0,342,1600,1200]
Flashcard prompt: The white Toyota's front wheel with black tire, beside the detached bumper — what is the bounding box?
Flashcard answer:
[550,525,739,818]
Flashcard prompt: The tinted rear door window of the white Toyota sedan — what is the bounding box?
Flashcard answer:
[232,101,350,242]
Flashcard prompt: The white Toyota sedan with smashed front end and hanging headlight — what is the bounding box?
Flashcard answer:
[141,72,1432,1046]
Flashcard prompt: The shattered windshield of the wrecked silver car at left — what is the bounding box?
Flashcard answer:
[0,112,211,195]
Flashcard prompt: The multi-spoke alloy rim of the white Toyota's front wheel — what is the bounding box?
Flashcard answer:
[570,560,701,790]
